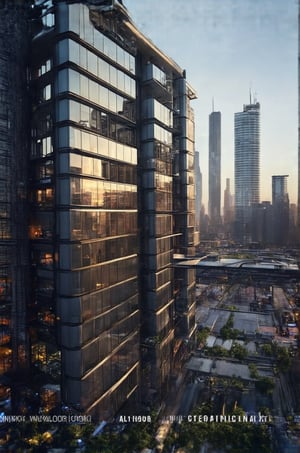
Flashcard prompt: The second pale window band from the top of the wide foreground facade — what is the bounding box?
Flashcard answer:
[58,39,136,98]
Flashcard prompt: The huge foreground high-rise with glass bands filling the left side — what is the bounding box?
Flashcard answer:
[0,0,197,419]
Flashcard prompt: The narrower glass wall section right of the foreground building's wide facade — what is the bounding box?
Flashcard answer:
[139,61,174,398]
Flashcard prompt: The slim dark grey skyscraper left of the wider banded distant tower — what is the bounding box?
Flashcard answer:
[208,112,221,224]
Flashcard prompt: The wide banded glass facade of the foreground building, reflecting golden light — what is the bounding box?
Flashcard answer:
[30,2,140,419]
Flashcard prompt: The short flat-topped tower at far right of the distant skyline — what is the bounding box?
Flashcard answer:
[272,175,290,245]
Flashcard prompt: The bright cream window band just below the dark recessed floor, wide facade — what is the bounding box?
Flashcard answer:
[58,127,137,164]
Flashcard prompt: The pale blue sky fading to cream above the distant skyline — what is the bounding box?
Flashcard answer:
[123,0,298,206]
